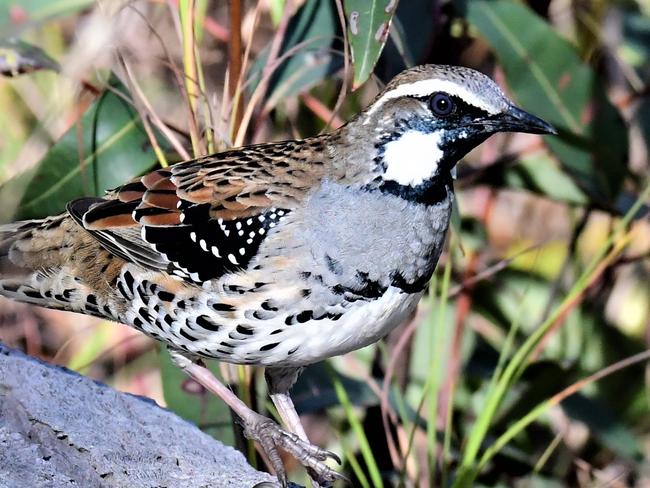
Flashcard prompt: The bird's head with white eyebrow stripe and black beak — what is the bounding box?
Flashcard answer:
[346,65,556,198]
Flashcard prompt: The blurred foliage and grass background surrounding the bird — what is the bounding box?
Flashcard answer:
[0,0,650,488]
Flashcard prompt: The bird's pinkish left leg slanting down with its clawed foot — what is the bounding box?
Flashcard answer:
[169,349,342,487]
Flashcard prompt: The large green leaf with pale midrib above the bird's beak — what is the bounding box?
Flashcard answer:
[467,0,628,206]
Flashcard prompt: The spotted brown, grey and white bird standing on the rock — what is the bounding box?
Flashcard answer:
[0,65,557,486]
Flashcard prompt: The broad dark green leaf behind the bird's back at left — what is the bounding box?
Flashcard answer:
[0,77,156,219]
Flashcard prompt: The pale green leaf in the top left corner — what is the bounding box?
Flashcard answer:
[0,0,95,32]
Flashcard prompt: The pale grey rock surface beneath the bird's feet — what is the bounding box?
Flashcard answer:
[0,344,277,488]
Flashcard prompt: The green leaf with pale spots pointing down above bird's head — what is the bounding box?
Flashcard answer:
[344,0,398,89]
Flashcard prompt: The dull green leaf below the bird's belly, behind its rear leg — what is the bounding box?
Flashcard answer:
[160,347,235,446]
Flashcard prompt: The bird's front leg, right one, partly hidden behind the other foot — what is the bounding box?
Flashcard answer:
[265,368,345,488]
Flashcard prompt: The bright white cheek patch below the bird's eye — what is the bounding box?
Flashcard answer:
[384,130,443,186]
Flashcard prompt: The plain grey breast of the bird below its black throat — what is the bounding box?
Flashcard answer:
[296,181,453,289]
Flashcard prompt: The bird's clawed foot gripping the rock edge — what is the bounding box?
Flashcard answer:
[244,414,348,487]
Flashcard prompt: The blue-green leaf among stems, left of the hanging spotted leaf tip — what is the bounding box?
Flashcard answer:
[249,0,343,107]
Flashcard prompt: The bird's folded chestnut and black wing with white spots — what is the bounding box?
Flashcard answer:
[68,137,324,284]
